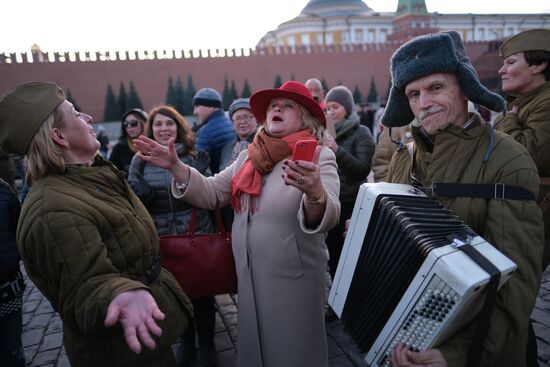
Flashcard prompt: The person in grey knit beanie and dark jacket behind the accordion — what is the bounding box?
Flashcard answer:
[325,86,375,278]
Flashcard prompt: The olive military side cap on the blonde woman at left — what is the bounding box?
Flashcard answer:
[0,82,65,155]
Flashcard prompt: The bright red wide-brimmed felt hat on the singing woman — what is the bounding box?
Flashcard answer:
[250,80,327,127]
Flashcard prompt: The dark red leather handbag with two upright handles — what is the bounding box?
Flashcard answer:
[159,207,237,298]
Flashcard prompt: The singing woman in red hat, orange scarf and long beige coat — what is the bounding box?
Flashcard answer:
[136,81,340,367]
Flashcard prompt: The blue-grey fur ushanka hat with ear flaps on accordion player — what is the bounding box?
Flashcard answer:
[382,31,505,127]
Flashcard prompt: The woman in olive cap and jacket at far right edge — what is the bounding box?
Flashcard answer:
[495,29,550,270]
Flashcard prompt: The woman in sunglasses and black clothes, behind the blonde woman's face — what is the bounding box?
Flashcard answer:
[109,108,147,175]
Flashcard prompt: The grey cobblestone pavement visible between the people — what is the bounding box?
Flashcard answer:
[23,268,550,367]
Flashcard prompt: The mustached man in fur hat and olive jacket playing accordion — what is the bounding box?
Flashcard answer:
[382,31,543,367]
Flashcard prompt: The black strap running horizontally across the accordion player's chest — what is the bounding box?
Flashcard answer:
[430,183,535,201]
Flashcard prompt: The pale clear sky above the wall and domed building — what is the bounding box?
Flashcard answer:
[0,0,550,52]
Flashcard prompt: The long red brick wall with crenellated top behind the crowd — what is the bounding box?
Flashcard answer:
[0,42,499,121]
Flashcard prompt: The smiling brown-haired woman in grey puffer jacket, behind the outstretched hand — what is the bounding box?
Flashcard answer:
[128,106,216,366]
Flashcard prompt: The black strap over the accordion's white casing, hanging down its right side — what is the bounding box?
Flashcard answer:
[451,238,500,367]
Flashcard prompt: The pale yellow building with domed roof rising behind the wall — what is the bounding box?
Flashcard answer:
[258,0,550,47]
